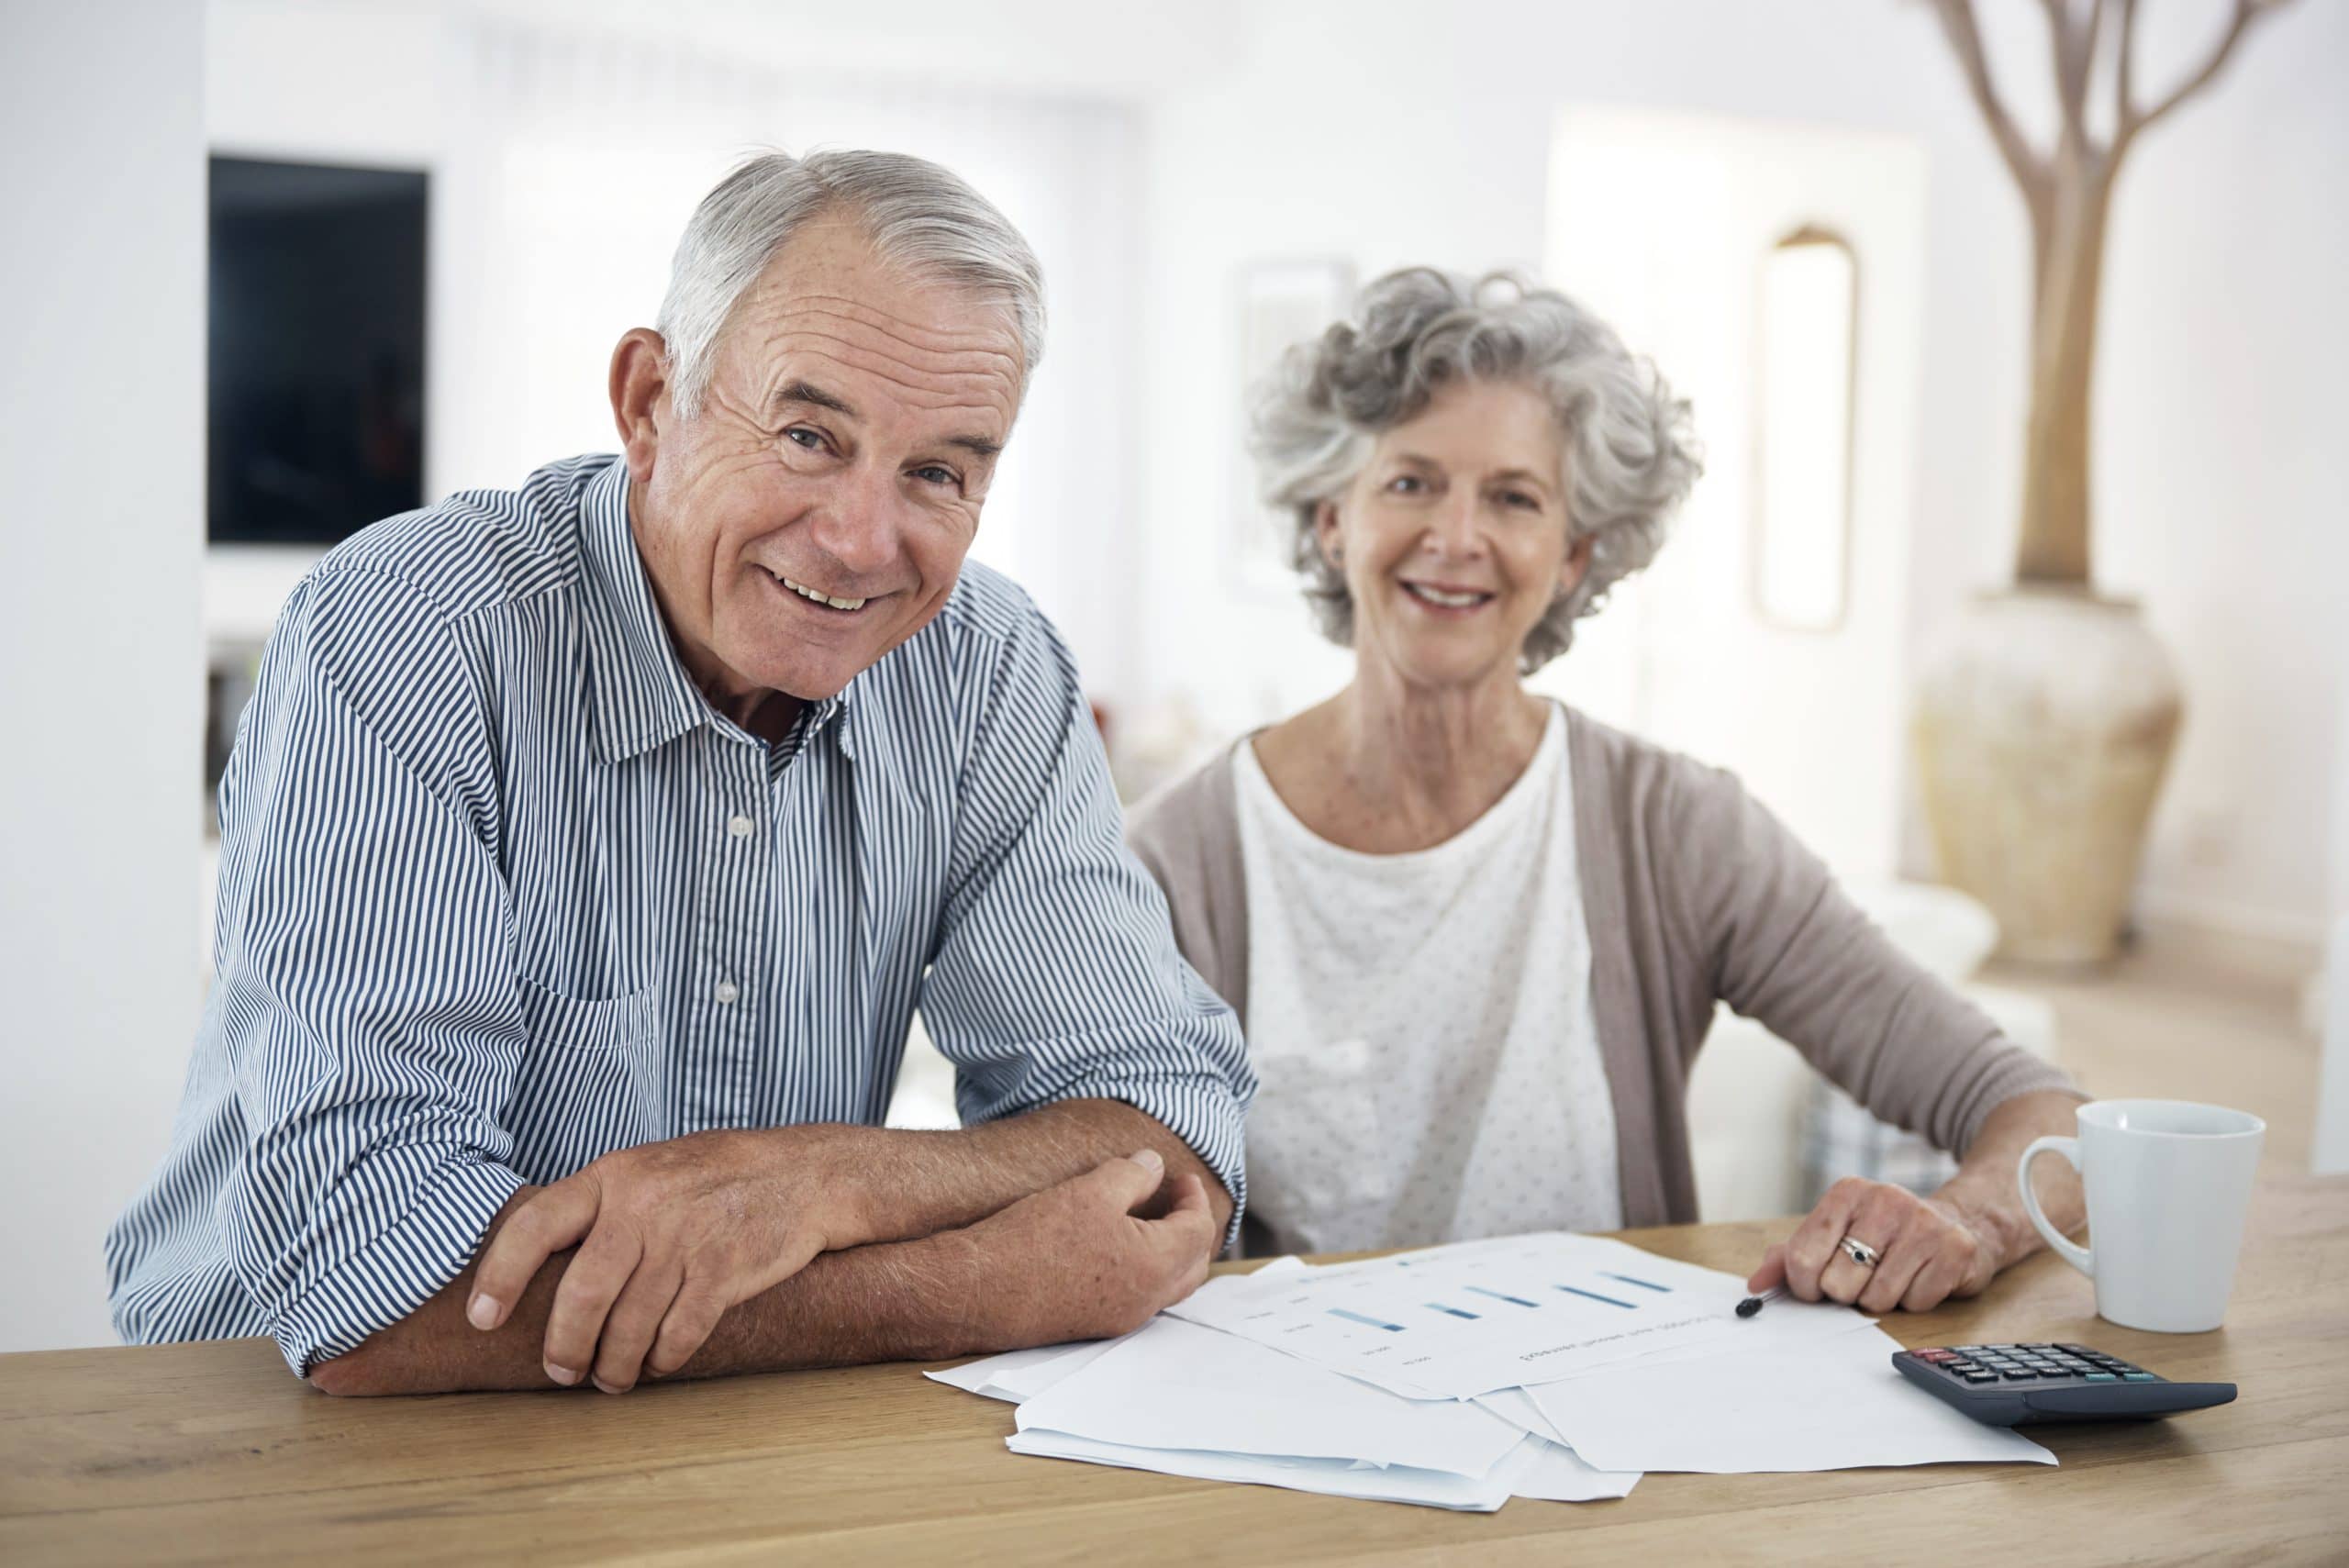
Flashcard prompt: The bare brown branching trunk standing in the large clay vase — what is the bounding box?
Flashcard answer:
[1926,0,2290,589]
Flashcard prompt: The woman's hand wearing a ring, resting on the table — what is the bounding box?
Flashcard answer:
[1745,1176,1999,1312]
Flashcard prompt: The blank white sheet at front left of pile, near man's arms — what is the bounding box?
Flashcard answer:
[1017,1317,1524,1476]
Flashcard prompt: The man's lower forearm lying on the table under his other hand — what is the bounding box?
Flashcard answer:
[310,1232,1000,1395]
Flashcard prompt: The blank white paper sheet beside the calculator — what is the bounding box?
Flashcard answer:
[1527,1303,2055,1474]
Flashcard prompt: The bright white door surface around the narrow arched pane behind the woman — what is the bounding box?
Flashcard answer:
[1534,108,1926,882]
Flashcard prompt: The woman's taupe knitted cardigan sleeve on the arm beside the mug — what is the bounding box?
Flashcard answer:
[1663,762,2086,1155]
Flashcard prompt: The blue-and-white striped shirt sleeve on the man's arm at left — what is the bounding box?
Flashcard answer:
[199,573,524,1373]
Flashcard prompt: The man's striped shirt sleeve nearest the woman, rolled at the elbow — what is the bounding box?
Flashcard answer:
[921,613,1257,1244]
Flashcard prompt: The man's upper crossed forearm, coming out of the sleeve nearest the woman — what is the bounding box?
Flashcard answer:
[841,1098,1230,1241]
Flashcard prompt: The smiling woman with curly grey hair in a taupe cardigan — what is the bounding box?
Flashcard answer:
[1130,270,2081,1312]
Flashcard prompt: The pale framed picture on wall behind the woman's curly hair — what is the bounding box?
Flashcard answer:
[1224,258,1353,596]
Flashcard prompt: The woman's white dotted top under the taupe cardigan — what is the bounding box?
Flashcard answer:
[1233,705,1623,1251]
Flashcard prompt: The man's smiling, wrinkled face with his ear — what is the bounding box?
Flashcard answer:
[629,218,1022,718]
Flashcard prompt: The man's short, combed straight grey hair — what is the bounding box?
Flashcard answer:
[653,150,1043,420]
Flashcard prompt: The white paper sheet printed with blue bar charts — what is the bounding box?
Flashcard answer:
[1167,1232,1855,1399]
